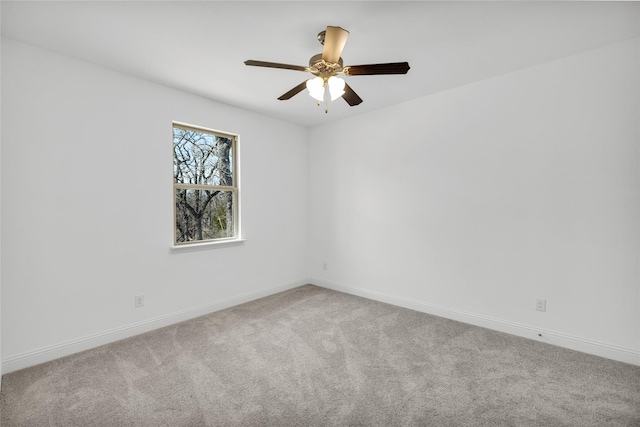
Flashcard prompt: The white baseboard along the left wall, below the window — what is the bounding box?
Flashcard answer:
[1,279,309,374]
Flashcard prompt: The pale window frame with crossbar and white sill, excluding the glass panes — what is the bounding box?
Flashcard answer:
[171,121,244,249]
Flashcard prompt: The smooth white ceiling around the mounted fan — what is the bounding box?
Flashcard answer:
[0,1,640,126]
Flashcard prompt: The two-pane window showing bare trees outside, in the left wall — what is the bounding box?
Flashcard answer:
[173,123,239,245]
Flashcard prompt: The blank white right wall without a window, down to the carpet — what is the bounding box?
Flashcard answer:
[309,39,640,364]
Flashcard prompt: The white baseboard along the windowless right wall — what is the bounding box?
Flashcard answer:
[311,279,640,366]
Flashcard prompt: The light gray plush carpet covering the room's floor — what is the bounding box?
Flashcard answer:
[1,285,640,427]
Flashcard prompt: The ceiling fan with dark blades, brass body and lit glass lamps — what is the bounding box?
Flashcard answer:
[244,26,409,113]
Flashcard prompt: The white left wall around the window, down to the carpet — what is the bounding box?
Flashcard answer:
[1,39,308,371]
